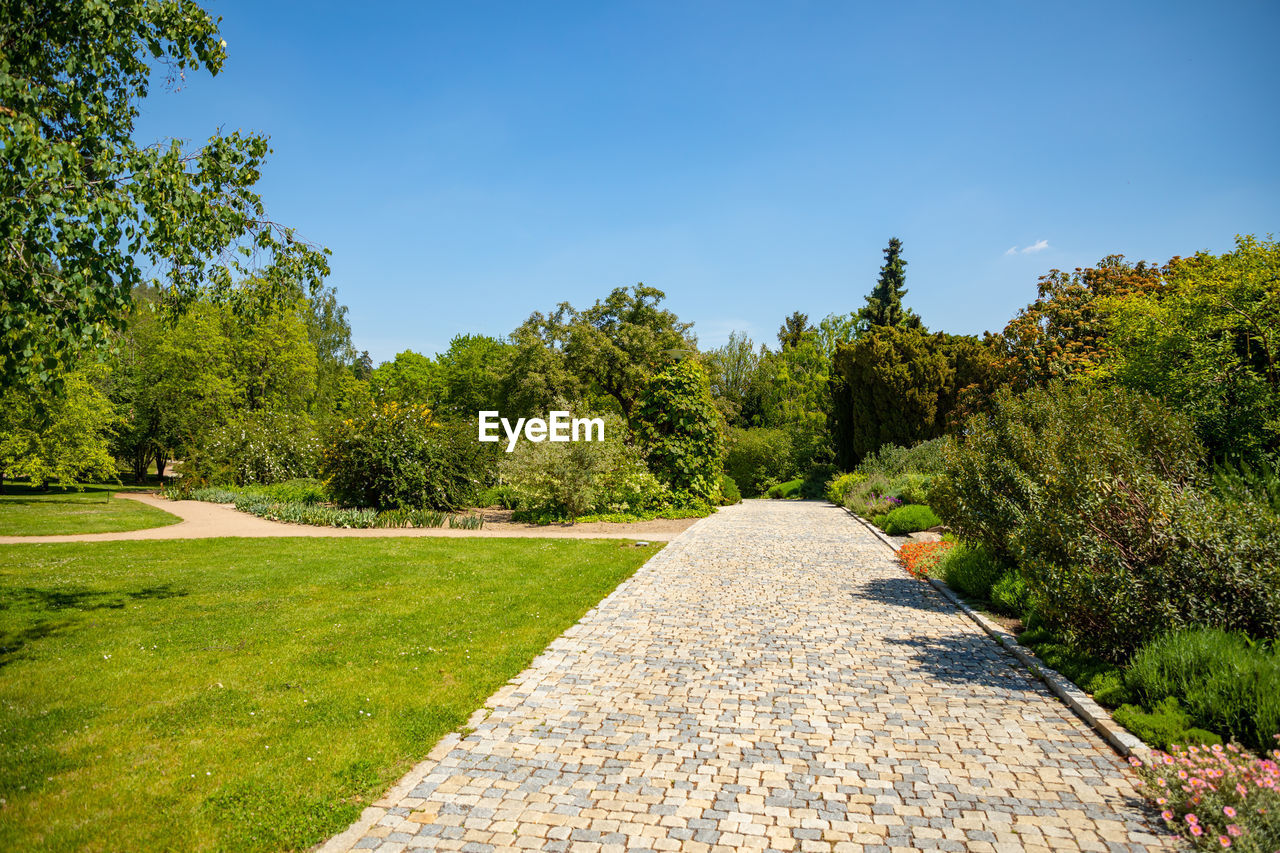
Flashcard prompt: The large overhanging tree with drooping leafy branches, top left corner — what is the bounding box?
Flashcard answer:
[0,0,328,384]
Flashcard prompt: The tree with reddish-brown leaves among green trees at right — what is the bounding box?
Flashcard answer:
[998,255,1164,392]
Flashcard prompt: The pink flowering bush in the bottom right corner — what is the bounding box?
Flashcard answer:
[1129,735,1280,853]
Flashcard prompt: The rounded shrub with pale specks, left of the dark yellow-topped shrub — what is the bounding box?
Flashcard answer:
[182,411,320,485]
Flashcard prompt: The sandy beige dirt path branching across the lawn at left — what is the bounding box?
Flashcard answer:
[0,493,698,544]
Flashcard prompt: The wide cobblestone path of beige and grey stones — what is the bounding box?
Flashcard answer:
[326,501,1167,853]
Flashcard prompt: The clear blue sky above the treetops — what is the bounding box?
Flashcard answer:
[137,0,1280,362]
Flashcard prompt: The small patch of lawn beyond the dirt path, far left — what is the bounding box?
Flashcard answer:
[0,483,182,537]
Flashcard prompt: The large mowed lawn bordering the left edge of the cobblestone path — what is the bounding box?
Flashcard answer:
[0,538,658,850]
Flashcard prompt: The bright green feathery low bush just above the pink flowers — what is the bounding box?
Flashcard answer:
[1125,629,1280,751]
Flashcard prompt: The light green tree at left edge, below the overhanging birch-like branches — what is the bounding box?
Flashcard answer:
[0,365,115,492]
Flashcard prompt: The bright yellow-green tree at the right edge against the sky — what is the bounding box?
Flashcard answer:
[1106,237,1280,461]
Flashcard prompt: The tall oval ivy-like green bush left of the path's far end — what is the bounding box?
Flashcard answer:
[636,359,724,502]
